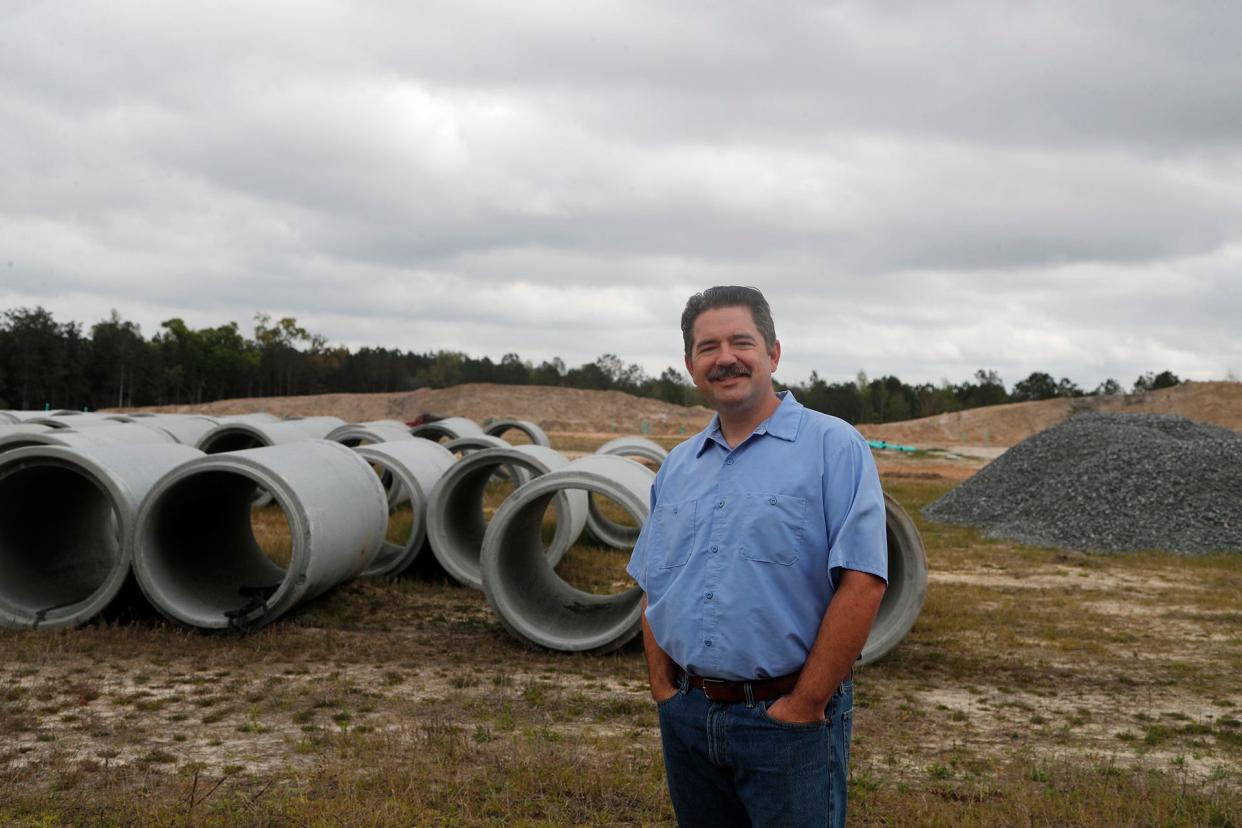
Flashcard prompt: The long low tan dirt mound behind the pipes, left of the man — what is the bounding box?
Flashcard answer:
[123,382,712,434]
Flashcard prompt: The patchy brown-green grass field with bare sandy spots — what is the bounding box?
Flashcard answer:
[0,456,1242,826]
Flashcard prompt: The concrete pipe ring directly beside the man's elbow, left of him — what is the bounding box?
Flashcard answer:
[479,454,655,653]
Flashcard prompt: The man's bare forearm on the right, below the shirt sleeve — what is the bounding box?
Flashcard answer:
[784,570,886,720]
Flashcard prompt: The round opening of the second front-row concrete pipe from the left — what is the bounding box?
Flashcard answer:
[142,469,294,627]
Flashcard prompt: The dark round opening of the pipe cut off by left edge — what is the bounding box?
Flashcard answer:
[0,462,122,623]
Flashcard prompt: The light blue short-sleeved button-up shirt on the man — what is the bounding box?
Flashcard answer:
[627,391,888,680]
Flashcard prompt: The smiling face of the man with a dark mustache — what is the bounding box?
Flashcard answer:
[686,305,780,412]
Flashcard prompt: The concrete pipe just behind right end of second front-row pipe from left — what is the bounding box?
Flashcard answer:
[354,439,457,577]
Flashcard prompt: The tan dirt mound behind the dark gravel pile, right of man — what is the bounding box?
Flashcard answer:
[858,382,1242,446]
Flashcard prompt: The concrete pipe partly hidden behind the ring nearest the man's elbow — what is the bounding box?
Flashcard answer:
[427,446,586,590]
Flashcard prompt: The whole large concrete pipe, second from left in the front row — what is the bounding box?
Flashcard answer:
[134,439,388,631]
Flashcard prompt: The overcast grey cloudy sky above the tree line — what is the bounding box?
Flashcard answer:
[0,0,1242,389]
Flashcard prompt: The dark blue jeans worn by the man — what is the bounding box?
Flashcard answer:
[660,679,853,828]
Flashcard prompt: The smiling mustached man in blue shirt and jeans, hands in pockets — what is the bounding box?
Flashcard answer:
[628,287,888,828]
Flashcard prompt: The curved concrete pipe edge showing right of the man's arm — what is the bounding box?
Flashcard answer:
[859,493,928,664]
